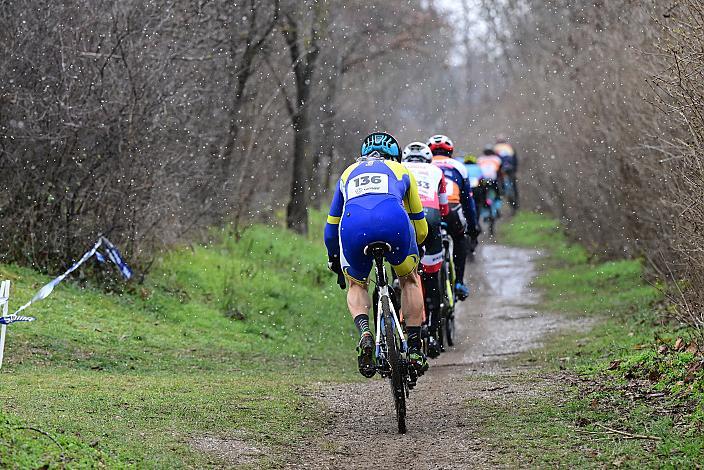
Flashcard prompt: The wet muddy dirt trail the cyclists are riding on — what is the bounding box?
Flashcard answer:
[287,245,584,469]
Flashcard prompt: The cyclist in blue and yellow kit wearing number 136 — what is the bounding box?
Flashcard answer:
[325,132,428,377]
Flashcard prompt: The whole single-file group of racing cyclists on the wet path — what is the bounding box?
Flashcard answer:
[325,132,517,377]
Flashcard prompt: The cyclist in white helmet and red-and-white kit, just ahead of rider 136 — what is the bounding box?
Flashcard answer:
[403,142,450,357]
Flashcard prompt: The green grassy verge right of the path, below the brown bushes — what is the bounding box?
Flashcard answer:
[477,213,704,468]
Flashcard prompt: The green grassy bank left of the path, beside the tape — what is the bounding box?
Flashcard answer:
[0,226,355,468]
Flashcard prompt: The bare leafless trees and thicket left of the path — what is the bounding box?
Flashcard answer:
[0,0,456,270]
